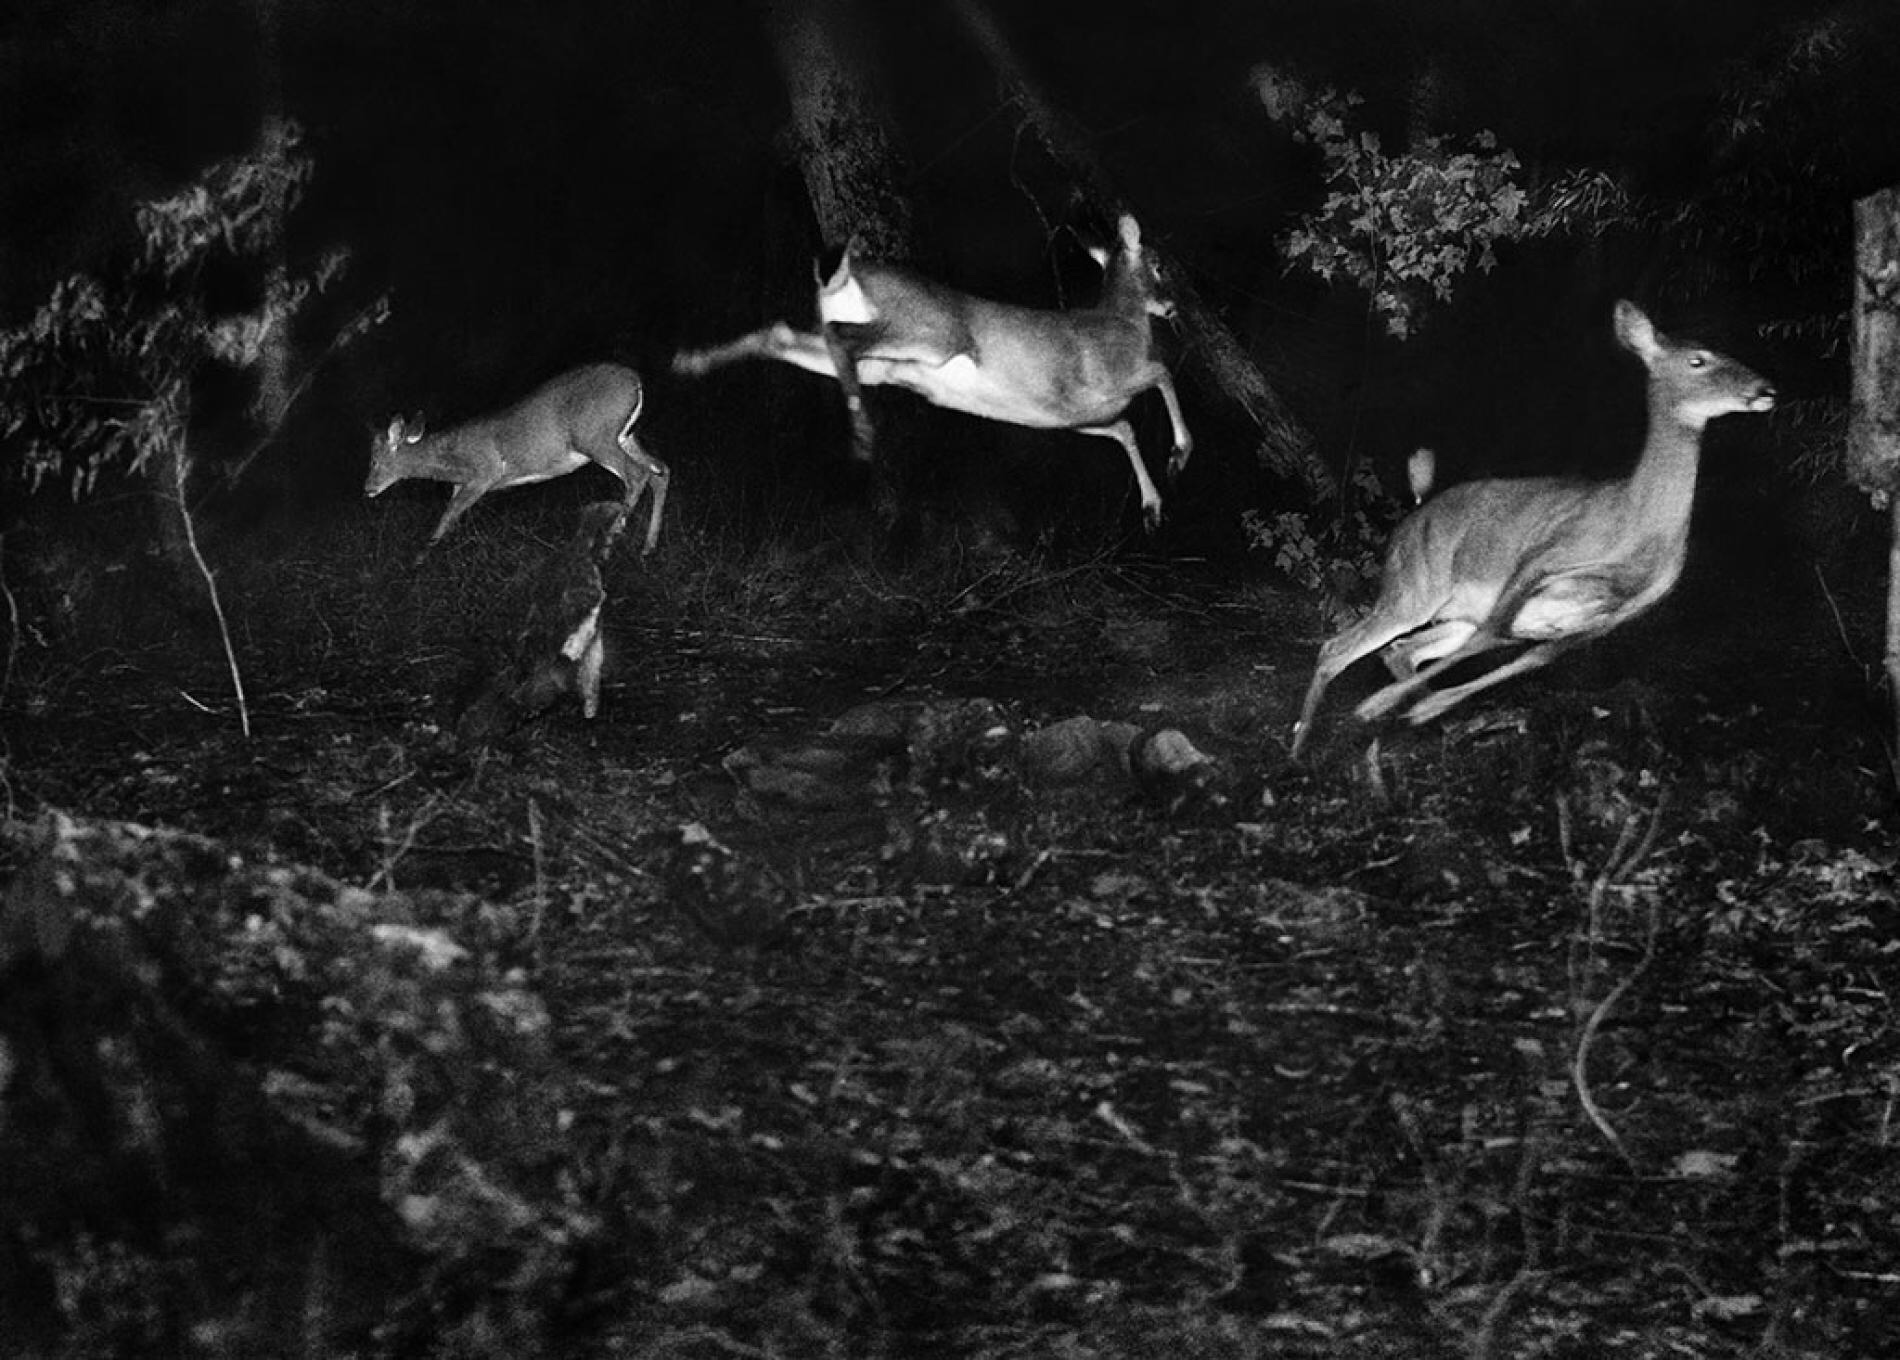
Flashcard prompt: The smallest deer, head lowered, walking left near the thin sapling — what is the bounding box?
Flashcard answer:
[363,363,669,553]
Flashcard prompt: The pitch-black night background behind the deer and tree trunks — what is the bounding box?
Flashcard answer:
[0,0,1900,538]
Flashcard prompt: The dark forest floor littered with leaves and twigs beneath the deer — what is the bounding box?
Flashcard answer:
[0,490,1900,1358]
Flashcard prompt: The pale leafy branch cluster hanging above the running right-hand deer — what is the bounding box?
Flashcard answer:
[1260,74,1621,336]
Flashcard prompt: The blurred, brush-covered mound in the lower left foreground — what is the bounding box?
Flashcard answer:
[0,813,595,1356]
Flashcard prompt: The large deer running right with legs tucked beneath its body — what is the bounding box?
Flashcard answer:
[1292,302,1775,758]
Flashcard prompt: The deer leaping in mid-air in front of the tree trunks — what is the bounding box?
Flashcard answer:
[673,215,1193,528]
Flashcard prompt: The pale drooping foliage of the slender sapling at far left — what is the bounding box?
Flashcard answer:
[0,122,382,500]
